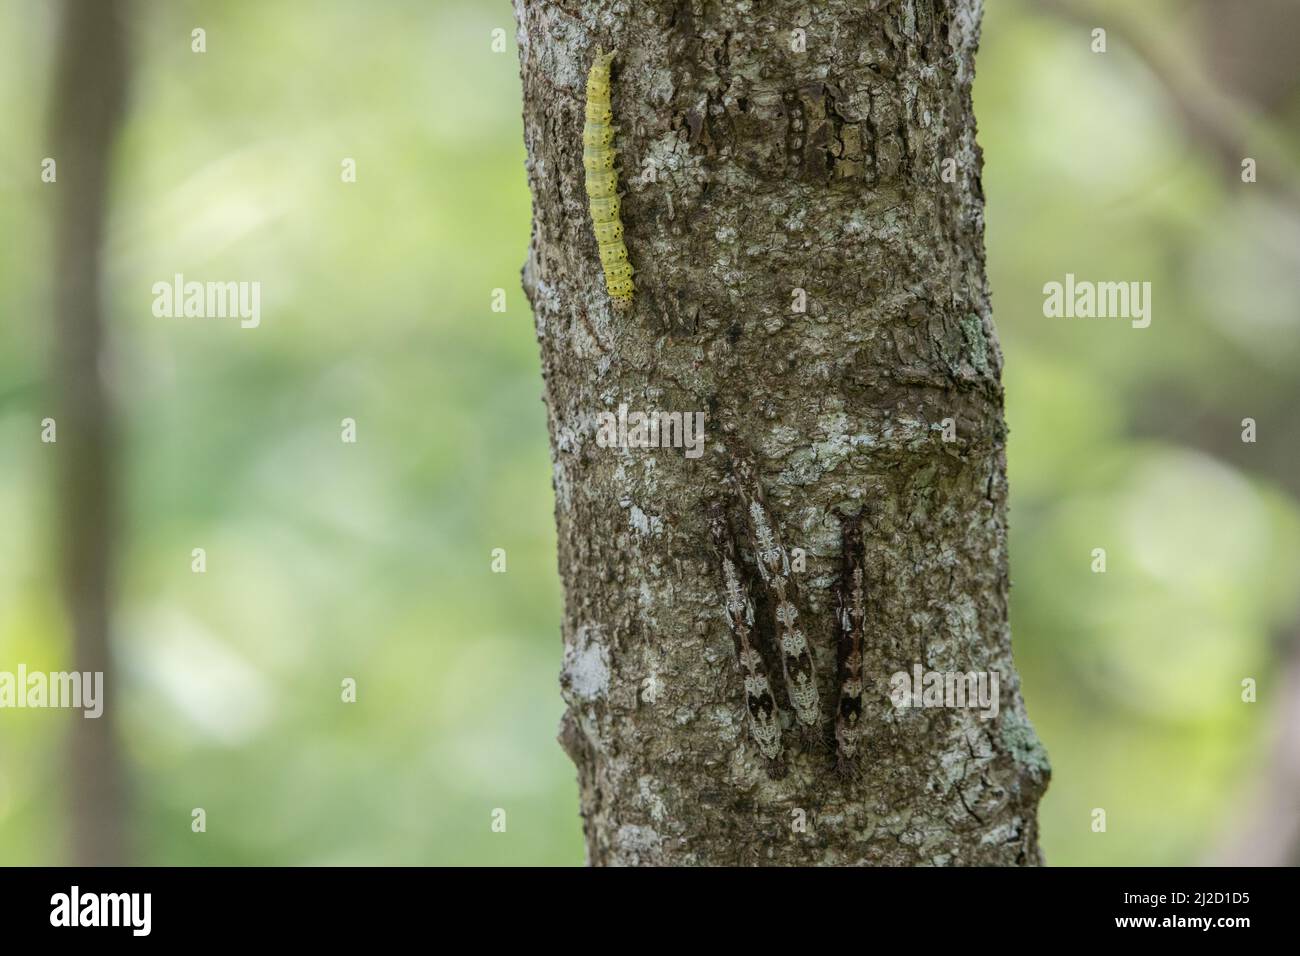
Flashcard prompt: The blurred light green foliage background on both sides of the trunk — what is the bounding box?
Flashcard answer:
[0,0,1300,865]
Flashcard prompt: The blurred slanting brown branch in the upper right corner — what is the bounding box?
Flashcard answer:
[1026,0,1300,219]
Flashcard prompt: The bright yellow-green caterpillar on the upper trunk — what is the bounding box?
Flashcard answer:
[582,47,636,308]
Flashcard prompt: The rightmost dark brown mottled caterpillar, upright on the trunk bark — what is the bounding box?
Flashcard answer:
[835,516,867,773]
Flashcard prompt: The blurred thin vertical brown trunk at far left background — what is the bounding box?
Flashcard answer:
[51,0,127,866]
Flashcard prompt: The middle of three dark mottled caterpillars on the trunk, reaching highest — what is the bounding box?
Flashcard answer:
[732,450,822,731]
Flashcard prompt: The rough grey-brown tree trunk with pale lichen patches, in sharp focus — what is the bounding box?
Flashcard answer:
[515,0,1049,865]
